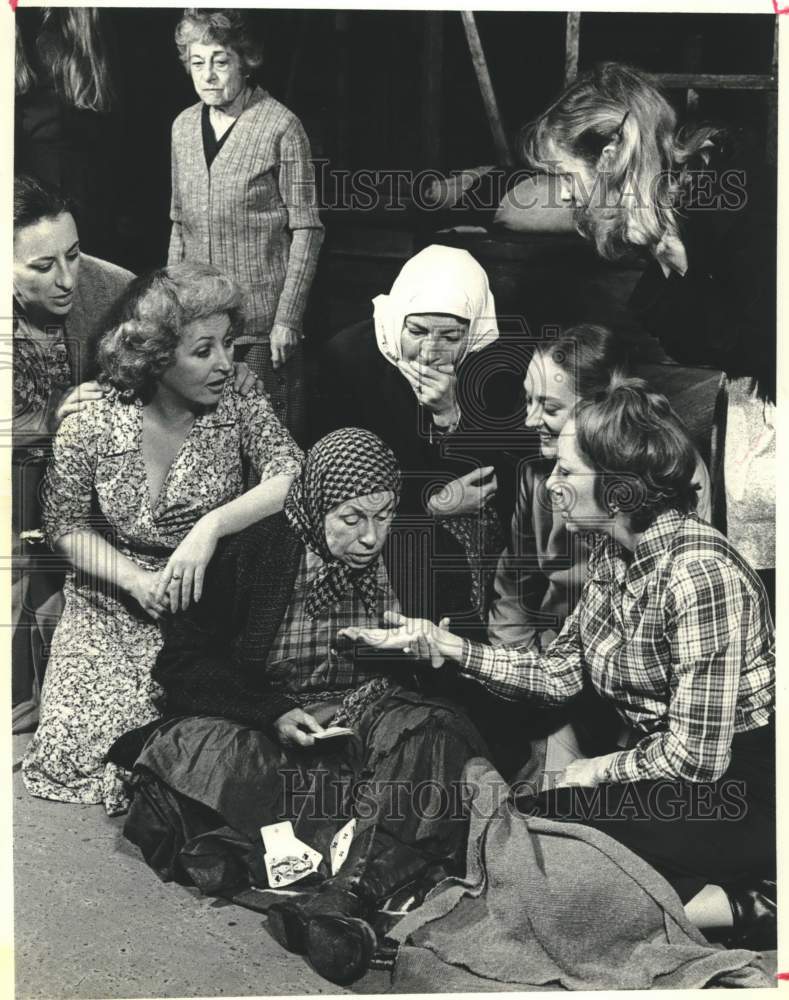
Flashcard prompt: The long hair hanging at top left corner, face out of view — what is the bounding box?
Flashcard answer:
[15,7,116,112]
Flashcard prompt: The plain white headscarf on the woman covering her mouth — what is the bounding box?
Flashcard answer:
[373,246,499,365]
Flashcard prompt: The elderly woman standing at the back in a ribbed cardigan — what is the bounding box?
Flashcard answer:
[168,8,323,438]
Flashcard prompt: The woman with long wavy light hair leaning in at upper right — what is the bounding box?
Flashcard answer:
[525,63,776,612]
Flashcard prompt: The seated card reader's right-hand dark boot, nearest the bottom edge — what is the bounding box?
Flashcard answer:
[306,844,429,986]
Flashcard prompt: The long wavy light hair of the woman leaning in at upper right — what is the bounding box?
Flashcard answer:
[522,62,721,259]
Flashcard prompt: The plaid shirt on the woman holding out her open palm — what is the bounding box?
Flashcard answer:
[461,511,775,781]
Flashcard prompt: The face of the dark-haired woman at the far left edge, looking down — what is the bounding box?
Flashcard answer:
[14,212,79,322]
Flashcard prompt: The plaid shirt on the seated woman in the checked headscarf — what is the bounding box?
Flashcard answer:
[266,548,400,702]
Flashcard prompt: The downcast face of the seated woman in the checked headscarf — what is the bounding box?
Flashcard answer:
[324,490,395,569]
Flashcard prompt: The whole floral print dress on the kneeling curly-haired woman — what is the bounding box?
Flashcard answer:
[22,384,301,815]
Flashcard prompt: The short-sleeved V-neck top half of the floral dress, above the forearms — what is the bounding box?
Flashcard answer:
[44,382,301,562]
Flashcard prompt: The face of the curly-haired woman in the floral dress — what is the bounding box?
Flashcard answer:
[159,313,233,407]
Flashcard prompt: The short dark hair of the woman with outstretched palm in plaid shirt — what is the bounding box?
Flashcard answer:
[574,375,698,531]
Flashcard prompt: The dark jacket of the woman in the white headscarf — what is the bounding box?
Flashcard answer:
[313,320,528,638]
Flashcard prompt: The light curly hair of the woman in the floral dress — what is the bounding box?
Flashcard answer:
[98,263,244,399]
